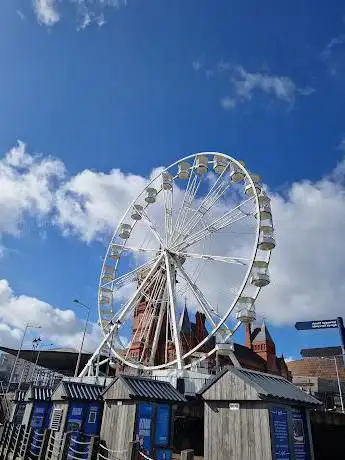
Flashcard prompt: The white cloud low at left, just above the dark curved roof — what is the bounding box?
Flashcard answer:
[0,279,101,350]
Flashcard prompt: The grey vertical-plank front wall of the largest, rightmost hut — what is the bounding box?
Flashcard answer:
[204,401,272,460]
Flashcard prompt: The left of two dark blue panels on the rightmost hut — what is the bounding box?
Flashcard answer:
[271,407,291,460]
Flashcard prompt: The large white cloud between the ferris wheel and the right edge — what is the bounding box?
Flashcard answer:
[258,163,345,324]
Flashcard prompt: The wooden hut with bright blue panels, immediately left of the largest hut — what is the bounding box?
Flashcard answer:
[100,375,186,460]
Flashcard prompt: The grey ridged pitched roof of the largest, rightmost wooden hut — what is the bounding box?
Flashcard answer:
[199,367,322,406]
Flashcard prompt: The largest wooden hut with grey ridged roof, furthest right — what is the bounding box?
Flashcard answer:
[199,367,321,460]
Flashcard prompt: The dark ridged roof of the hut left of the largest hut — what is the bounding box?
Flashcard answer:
[119,375,186,402]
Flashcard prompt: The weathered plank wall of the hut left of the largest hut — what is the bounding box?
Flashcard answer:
[101,395,136,458]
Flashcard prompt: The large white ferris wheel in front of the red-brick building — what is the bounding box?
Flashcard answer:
[81,152,275,376]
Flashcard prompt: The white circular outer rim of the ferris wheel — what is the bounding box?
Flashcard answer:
[98,152,264,371]
